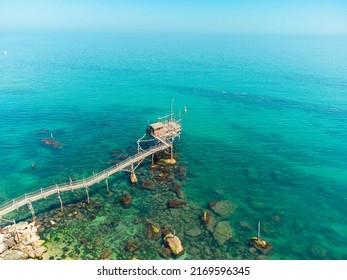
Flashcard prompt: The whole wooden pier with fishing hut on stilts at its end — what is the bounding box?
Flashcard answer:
[0,113,182,221]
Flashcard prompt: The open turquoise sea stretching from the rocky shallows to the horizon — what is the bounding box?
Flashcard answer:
[0,33,347,259]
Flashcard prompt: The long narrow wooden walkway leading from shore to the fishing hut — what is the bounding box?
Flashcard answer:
[0,140,172,218]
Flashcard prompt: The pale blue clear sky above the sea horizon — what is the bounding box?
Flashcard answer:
[0,0,347,34]
